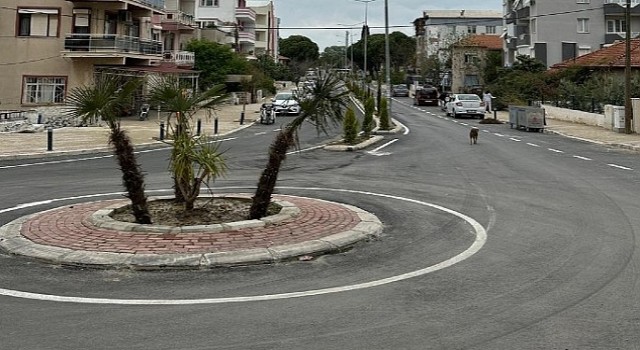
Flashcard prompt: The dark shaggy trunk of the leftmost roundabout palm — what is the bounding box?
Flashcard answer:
[109,127,151,224]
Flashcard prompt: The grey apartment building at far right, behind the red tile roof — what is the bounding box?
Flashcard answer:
[503,0,640,67]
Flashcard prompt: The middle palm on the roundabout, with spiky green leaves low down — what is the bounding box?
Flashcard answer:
[150,77,227,210]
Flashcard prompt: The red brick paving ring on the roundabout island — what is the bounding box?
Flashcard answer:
[21,195,360,254]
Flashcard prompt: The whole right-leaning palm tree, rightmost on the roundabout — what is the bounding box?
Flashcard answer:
[249,74,349,219]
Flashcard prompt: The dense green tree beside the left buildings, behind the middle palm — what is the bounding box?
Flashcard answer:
[186,39,249,90]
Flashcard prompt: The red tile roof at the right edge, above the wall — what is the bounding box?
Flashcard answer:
[551,39,640,69]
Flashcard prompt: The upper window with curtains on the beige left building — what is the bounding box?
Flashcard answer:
[17,8,60,37]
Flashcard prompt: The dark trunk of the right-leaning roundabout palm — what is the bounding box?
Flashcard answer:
[249,128,294,219]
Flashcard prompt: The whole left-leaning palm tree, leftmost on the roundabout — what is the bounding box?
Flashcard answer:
[67,75,151,224]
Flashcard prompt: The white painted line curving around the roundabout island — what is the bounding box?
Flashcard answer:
[0,187,487,305]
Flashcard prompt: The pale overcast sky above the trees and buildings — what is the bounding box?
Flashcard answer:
[274,0,502,52]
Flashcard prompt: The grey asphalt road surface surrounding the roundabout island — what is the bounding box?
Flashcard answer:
[0,99,640,350]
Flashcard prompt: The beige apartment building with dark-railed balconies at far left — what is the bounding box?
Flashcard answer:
[0,0,202,116]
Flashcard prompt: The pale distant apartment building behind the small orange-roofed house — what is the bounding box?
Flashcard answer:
[414,9,503,66]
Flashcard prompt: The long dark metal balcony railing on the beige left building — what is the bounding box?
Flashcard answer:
[64,34,162,55]
